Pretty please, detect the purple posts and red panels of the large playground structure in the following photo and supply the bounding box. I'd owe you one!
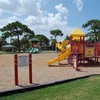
[68,36,100,70]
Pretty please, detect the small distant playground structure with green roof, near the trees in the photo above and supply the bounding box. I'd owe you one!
[29,38,39,54]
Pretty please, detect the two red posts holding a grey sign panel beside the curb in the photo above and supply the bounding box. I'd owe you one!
[14,54,32,85]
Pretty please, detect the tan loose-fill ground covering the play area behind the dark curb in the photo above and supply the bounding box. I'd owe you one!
[0,52,100,92]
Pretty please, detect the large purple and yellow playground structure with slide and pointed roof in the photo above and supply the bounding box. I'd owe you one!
[48,28,100,70]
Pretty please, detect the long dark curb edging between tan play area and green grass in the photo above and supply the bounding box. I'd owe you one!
[0,74,100,97]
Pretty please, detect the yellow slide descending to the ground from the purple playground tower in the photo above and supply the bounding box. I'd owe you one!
[48,45,71,65]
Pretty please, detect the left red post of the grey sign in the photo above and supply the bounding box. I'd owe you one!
[14,54,18,85]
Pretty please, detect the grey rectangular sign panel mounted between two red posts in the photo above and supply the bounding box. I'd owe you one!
[18,55,29,67]
